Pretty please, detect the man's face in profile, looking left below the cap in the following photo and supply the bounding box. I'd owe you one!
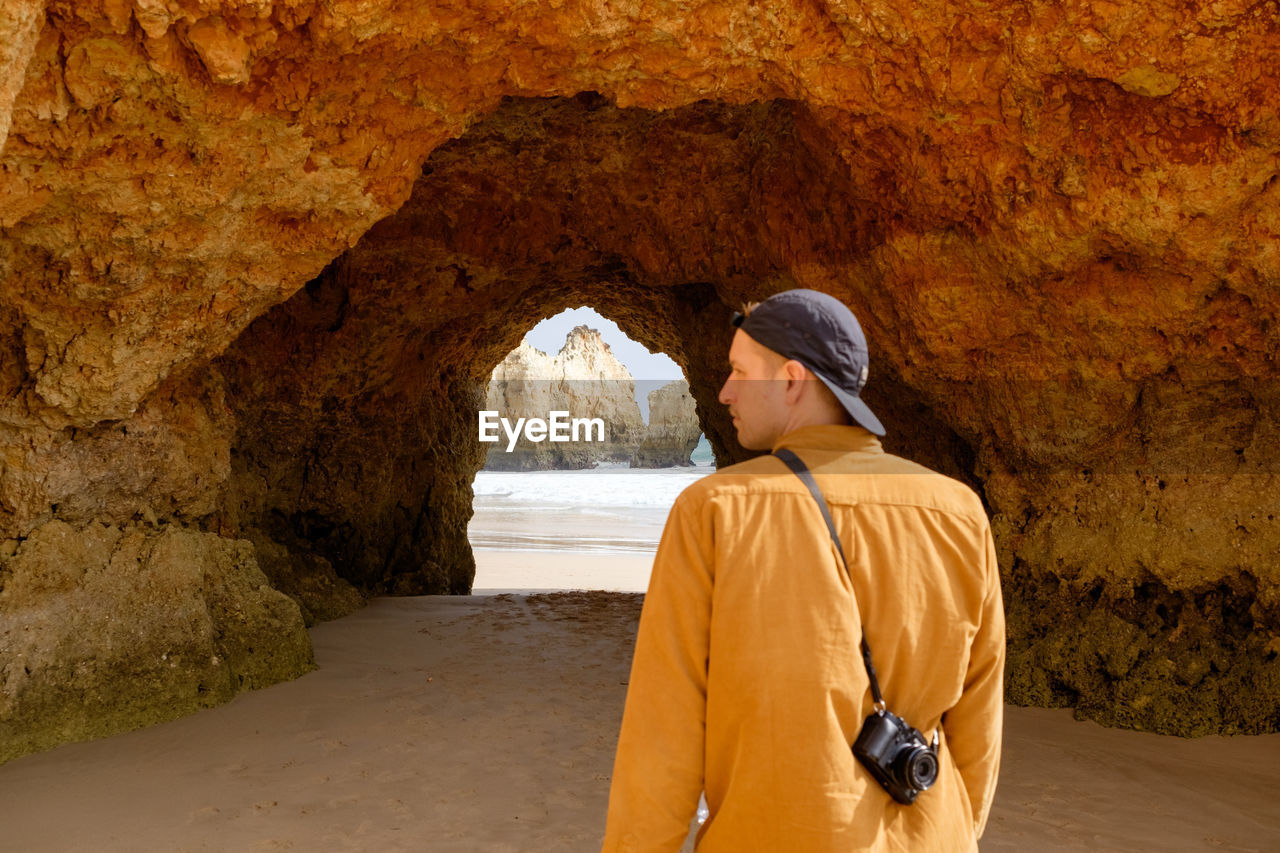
[719,329,787,450]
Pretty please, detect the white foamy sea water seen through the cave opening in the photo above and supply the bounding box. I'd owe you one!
[467,465,716,555]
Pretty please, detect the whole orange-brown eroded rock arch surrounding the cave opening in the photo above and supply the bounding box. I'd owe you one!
[0,0,1280,754]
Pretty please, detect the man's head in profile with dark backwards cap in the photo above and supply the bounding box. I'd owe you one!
[719,289,884,450]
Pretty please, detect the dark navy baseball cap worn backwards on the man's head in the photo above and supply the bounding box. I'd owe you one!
[733,289,884,435]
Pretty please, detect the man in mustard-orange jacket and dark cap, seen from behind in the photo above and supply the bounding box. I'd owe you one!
[604,289,1005,853]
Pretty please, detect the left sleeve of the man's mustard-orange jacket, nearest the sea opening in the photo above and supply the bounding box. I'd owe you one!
[603,498,713,853]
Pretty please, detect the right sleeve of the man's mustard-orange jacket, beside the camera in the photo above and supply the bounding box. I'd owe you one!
[943,528,1005,838]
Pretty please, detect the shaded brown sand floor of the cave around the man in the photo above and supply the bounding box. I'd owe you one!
[0,555,1280,852]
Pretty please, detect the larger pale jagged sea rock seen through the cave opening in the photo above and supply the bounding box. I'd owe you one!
[485,325,645,471]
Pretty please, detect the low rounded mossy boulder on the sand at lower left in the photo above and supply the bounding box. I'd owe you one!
[0,520,314,762]
